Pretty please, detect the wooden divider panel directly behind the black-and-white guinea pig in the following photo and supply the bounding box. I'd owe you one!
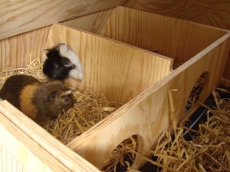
[43,24,173,103]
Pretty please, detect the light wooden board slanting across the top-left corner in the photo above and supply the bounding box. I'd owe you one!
[0,0,125,40]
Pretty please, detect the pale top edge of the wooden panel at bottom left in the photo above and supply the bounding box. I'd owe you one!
[0,100,99,172]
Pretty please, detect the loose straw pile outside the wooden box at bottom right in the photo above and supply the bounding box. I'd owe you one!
[131,89,230,172]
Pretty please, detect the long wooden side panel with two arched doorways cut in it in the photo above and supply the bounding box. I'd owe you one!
[67,33,230,169]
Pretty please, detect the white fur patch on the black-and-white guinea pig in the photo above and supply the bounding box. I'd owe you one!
[59,44,83,80]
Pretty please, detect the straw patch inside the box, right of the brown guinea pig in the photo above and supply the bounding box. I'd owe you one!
[44,88,121,144]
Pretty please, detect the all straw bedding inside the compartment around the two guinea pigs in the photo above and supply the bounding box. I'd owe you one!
[0,58,121,144]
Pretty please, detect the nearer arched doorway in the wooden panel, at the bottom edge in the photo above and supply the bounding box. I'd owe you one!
[102,135,139,172]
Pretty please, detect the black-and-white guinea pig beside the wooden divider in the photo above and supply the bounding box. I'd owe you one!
[43,43,83,81]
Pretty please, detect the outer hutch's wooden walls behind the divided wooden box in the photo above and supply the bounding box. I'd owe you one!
[0,0,230,80]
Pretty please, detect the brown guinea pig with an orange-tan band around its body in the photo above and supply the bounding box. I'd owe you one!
[0,75,75,125]
